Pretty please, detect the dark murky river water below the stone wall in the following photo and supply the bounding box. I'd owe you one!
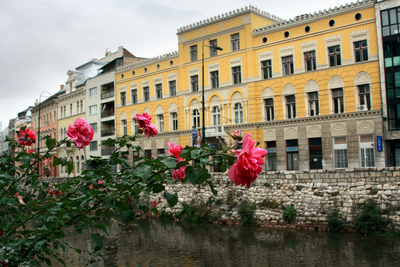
[55,219,400,267]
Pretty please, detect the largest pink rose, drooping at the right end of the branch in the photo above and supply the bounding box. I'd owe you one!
[228,133,267,188]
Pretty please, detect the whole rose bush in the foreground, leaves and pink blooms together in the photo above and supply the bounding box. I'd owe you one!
[0,114,266,266]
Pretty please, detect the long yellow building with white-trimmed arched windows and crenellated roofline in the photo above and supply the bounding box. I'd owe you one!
[116,1,384,171]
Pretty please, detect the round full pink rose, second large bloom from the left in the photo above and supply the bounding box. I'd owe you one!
[66,117,94,148]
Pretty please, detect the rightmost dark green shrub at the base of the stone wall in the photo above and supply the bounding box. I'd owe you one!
[355,199,390,235]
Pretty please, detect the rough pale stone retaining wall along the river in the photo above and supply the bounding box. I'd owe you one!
[159,168,400,230]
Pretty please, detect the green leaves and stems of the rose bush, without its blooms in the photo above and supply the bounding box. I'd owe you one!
[0,128,238,266]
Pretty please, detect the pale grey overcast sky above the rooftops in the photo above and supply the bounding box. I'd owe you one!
[0,0,344,128]
